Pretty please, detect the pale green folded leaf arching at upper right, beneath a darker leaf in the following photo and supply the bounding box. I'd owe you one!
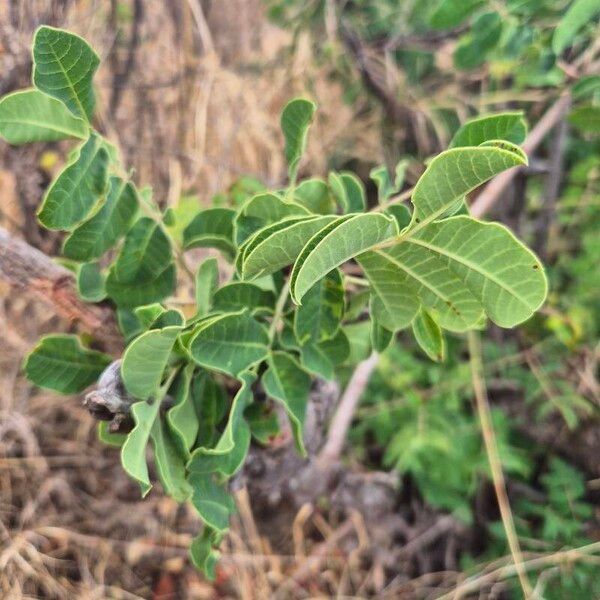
[412,142,527,222]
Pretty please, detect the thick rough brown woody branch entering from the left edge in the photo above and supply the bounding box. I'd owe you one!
[0,227,123,354]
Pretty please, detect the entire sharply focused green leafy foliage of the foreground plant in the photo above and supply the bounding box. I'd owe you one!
[0,26,547,574]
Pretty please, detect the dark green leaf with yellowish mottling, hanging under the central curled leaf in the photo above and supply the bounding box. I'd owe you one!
[294,269,344,344]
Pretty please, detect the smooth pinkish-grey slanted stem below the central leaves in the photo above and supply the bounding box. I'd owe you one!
[318,352,379,464]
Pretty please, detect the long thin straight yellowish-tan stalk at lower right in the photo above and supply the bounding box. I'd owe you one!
[468,331,533,598]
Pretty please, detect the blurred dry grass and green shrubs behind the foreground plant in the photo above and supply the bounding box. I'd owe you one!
[0,0,600,599]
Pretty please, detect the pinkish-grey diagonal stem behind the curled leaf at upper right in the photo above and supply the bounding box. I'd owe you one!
[471,91,571,217]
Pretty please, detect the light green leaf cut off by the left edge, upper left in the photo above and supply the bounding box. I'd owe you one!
[0,89,89,145]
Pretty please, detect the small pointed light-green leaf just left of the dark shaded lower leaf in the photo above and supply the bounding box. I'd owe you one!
[166,364,199,458]
